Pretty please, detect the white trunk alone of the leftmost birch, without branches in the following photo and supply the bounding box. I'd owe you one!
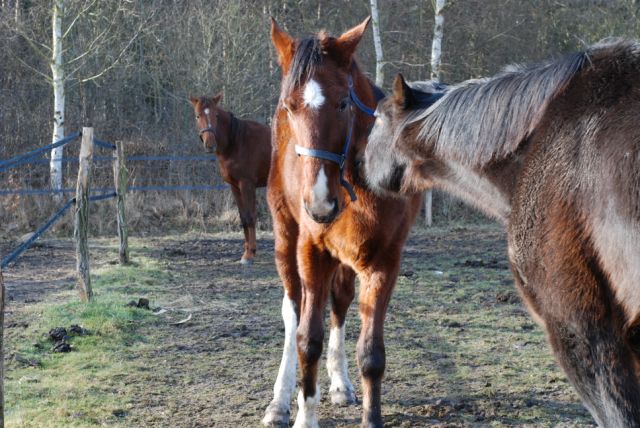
[49,0,64,194]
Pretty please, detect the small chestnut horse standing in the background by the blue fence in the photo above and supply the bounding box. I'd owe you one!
[189,93,271,264]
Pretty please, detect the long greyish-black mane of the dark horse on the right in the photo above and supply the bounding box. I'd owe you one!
[404,40,640,166]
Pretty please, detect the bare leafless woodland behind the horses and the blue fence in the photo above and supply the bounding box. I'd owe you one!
[0,0,640,237]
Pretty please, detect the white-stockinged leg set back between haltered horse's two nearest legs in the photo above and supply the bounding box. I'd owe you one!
[327,265,356,405]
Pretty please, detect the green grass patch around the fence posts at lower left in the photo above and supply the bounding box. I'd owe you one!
[5,257,170,427]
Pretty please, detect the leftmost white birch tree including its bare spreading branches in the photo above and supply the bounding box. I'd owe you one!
[8,0,146,190]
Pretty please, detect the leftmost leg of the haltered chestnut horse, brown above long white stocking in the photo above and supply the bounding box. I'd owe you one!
[262,213,300,427]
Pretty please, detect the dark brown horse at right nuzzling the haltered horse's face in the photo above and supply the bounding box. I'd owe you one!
[365,41,640,428]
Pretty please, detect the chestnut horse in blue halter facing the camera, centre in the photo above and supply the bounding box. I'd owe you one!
[263,19,420,427]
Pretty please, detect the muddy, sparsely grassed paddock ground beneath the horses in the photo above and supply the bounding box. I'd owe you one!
[0,226,593,427]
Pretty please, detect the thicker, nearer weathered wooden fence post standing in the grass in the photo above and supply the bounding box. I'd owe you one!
[73,128,93,302]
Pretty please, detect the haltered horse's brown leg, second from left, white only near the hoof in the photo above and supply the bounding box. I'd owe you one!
[294,241,337,428]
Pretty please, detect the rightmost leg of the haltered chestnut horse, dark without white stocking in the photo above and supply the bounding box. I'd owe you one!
[357,257,399,428]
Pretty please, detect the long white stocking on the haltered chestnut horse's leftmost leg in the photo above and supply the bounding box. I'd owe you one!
[262,292,298,426]
